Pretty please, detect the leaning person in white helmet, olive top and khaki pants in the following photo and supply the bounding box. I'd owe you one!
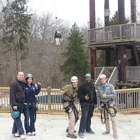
[60,76,79,139]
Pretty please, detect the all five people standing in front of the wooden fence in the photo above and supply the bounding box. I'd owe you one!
[10,72,118,139]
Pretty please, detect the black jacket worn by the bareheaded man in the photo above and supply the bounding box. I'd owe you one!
[10,79,25,106]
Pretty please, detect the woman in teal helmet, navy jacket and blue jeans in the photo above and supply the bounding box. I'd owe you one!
[24,74,41,136]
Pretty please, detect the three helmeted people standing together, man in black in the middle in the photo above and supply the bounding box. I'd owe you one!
[60,73,118,139]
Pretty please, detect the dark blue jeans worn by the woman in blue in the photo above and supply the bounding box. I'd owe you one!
[24,107,35,133]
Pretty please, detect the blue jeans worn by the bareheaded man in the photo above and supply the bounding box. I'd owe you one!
[12,104,24,135]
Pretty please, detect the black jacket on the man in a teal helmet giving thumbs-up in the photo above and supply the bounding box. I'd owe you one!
[78,82,97,104]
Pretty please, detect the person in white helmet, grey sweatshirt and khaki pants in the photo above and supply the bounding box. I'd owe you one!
[97,74,118,139]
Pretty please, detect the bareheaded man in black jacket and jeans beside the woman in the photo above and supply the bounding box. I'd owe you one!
[10,72,26,139]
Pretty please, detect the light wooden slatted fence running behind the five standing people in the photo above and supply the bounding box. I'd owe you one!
[0,88,140,114]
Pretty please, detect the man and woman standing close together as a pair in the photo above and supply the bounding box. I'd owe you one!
[10,72,41,139]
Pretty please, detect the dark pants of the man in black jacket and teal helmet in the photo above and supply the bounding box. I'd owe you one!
[79,103,94,133]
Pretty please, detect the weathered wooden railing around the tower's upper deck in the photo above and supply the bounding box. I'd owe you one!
[88,23,140,44]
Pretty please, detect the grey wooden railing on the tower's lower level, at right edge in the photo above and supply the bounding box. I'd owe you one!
[126,66,140,82]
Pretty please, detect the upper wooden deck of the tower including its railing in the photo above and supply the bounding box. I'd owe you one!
[88,23,140,49]
